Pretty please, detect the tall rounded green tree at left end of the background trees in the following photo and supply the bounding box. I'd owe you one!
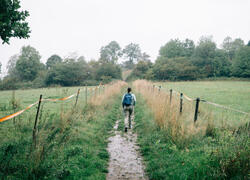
[16,46,44,81]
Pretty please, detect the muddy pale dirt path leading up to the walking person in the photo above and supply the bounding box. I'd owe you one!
[106,121,148,180]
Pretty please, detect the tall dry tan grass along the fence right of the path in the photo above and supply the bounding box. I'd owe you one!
[133,80,212,143]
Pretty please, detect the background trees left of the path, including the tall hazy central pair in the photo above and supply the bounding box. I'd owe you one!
[0,41,149,90]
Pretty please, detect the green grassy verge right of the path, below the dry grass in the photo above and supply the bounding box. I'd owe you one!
[135,94,250,179]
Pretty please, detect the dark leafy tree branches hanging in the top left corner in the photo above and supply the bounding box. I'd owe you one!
[0,0,30,44]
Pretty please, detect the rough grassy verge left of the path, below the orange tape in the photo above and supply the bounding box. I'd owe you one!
[0,83,125,179]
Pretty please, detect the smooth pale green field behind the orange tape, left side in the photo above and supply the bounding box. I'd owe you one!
[0,87,100,121]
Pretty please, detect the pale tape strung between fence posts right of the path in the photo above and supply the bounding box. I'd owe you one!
[153,85,250,115]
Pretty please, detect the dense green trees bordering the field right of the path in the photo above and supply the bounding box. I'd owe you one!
[128,36,250,80]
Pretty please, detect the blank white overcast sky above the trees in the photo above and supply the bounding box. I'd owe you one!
[0,0,250,74]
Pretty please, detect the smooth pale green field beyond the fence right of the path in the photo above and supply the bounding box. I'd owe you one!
[155,81,250,126]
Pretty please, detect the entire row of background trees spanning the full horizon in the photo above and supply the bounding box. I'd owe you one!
[0,36,250,90]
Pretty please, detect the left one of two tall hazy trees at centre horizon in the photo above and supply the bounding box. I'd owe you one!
[100,41,122,64]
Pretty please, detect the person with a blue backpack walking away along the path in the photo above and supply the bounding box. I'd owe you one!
[122,87,136,132]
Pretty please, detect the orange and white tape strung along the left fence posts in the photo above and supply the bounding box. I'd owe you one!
[0,85,104,123]
